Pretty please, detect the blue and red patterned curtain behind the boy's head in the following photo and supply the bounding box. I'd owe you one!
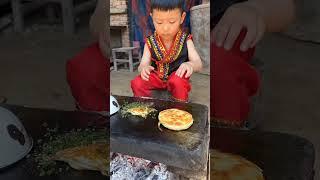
[129,0,202,47]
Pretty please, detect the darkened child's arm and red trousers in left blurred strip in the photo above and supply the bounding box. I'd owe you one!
[66,0,110,113]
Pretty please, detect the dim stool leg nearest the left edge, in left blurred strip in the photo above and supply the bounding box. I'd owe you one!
[11,0,24,32]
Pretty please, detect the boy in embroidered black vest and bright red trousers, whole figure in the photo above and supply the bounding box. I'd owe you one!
[131,0,202,101]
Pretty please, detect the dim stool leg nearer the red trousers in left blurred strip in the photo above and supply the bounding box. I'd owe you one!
[61,0,75,34]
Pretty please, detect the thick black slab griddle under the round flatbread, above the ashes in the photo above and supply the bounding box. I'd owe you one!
[110,96,209,171]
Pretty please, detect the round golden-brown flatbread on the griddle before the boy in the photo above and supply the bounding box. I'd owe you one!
[158,108,193,131]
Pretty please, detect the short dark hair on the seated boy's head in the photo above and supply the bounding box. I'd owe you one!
[151,0,185,12]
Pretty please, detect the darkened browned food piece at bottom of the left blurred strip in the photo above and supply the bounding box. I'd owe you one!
[53,143,109,176]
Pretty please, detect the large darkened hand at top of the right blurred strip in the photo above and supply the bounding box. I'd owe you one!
[213,2,266,51]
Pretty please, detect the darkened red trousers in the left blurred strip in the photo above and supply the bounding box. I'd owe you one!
[66,43,110,111]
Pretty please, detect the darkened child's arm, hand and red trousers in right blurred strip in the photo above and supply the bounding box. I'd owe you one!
[211,0,294,126]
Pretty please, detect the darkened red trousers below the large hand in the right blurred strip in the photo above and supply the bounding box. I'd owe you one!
[210,31,260,124]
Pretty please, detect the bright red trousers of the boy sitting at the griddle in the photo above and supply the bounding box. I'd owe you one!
[131,72,191,101]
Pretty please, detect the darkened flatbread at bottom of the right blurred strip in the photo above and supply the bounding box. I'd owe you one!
[210,150,264,180]
